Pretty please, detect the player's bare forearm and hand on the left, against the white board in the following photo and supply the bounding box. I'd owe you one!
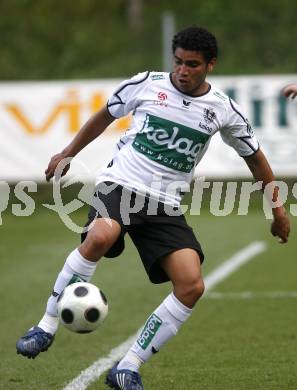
[45,107,115,181]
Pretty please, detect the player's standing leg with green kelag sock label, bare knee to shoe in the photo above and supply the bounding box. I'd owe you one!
[106,248,204,390]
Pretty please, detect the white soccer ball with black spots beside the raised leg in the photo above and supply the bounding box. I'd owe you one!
[58,282,108,333]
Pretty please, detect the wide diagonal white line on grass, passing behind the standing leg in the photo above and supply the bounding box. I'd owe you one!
[63,241,266,390]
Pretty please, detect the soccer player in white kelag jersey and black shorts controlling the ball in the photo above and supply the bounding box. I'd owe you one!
[17,27,290,390]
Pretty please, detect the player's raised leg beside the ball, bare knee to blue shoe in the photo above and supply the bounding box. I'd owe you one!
[16,218,121,358]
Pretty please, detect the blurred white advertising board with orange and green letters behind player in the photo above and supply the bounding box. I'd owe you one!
[0,75,297,181]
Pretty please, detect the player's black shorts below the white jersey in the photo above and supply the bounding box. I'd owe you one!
[81,182,204,283]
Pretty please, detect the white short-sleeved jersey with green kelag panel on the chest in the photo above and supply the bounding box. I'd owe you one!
[96,72,259,206]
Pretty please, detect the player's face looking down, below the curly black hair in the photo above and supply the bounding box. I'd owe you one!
[172,47,216,96]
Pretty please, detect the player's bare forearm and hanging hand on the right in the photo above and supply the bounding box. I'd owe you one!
[244,149,290,243]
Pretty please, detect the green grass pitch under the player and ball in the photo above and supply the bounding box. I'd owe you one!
[0,210,297,390]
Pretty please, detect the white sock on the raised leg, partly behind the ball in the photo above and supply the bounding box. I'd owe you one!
[38,249,97,334]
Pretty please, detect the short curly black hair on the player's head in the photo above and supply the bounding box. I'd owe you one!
[172,26,218,62]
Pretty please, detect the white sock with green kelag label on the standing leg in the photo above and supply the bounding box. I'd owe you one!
[118,293,192,372]
